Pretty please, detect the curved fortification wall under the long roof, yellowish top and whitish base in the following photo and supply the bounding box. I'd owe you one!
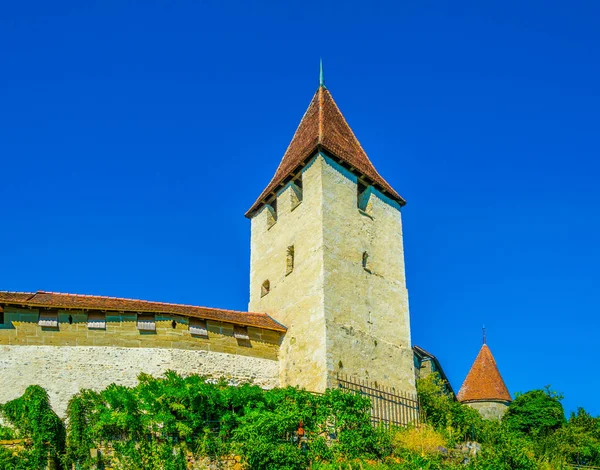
[0,307,280,415]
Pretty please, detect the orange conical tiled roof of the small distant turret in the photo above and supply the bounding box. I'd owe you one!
[456,344,512,402]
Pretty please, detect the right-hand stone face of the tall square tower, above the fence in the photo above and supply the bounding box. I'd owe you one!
[322,158,415,394]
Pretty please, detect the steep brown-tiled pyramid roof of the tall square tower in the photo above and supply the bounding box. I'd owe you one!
[246,86,406,217]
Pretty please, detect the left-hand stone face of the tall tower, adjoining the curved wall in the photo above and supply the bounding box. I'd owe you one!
[248,158,327,391]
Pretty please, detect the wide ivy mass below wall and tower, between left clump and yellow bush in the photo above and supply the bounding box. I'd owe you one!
[61,372,380,470]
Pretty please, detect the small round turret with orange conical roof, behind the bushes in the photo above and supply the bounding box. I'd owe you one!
[456,343,512,419]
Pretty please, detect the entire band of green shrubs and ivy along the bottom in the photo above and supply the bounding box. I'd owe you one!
[0,372,600,470]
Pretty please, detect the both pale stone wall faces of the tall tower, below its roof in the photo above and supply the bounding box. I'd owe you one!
[249,154,415,394]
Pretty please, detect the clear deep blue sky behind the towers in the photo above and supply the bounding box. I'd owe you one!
[0,0,600,415]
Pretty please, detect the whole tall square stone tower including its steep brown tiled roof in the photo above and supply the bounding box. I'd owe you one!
[246,75,415,393]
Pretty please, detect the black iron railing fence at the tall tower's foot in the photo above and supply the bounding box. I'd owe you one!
[336,374,421,426]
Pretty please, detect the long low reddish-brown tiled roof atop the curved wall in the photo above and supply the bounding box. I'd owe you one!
[0,291,286,332]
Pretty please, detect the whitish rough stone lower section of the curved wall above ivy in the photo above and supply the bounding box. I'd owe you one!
[0,345,279,416]
